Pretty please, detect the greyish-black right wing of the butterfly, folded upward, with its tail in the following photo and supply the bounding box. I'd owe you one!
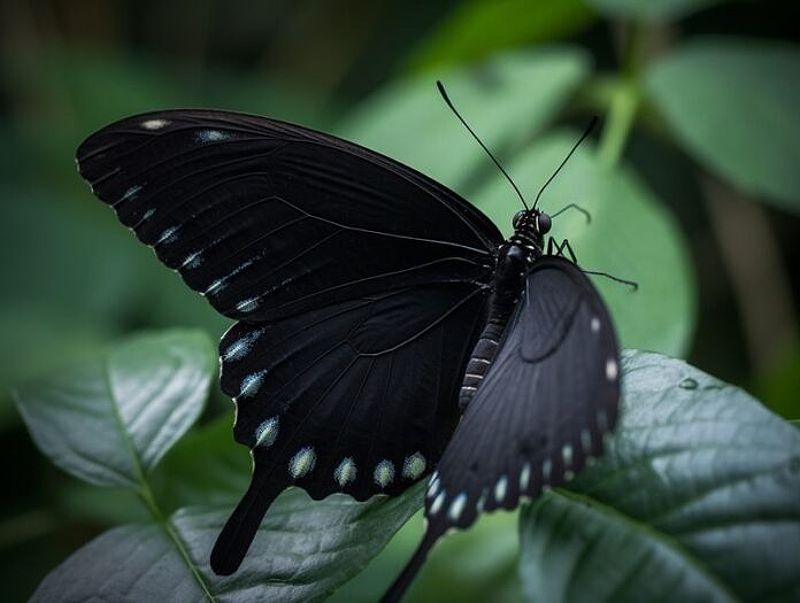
[384,256,620,601]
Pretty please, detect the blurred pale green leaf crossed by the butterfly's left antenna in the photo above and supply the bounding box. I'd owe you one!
[341,49,588,194]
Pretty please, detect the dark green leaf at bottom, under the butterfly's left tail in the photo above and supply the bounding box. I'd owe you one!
[31,484,424,603]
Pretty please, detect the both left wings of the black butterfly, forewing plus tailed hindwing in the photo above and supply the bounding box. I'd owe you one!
[73,111,501,574]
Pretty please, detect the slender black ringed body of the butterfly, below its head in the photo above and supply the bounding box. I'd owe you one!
[458,243,525,413]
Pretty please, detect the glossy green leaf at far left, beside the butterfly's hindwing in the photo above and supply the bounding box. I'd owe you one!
[15,330,215,488]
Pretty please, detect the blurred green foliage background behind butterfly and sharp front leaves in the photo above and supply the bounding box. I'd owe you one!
[0,0,800,601]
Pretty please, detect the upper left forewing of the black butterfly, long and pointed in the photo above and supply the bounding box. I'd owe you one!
[78,111,500,321]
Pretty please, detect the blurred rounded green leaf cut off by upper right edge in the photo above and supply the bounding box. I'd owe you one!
[645,39,800,212]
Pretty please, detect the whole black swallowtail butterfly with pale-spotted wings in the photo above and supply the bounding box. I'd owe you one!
[77,88,619,599]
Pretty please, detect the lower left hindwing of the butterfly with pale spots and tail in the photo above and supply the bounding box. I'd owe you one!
[211,285,486,574]
